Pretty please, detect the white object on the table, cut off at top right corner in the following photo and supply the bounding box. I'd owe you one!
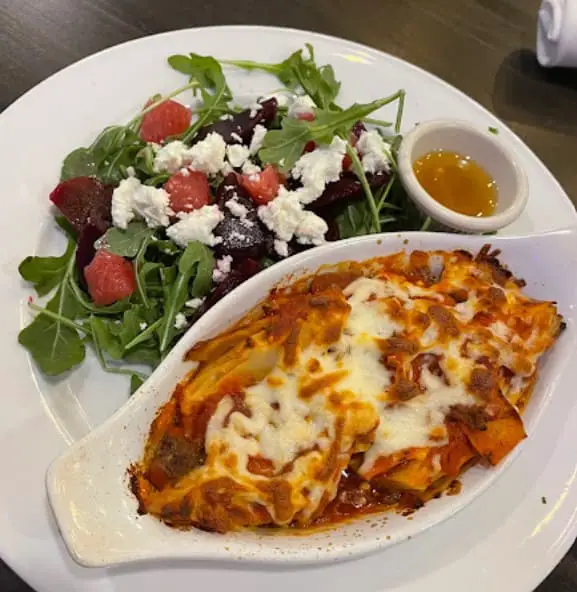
[537,0,577,68]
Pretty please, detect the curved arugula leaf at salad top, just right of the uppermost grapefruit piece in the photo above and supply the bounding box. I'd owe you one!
[168,53,232,142]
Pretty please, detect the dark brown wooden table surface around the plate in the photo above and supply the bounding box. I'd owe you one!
[0,0,577,592]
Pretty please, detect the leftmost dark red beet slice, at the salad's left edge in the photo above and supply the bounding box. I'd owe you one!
[50,177,113,234]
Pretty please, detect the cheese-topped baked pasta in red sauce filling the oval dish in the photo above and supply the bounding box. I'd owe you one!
[130,246,564,533]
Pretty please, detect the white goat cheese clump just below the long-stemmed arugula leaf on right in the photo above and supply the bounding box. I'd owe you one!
[292,136,347,205]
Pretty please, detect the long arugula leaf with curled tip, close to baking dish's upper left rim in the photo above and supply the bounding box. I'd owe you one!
[159,241,214,353]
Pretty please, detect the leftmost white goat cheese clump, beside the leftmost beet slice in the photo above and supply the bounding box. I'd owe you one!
[110,177,173,230]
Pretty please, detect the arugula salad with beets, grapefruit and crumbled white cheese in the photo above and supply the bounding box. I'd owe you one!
[18,45,428,391]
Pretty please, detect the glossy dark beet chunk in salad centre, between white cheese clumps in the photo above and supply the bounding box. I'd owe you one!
[214,173,270,259]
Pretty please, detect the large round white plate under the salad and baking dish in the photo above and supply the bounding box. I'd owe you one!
[0,27,577,592]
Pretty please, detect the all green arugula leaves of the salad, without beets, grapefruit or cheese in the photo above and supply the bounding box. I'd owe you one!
[18,44,432,392]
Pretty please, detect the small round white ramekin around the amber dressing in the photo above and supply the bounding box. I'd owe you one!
[397,119,529,234]
